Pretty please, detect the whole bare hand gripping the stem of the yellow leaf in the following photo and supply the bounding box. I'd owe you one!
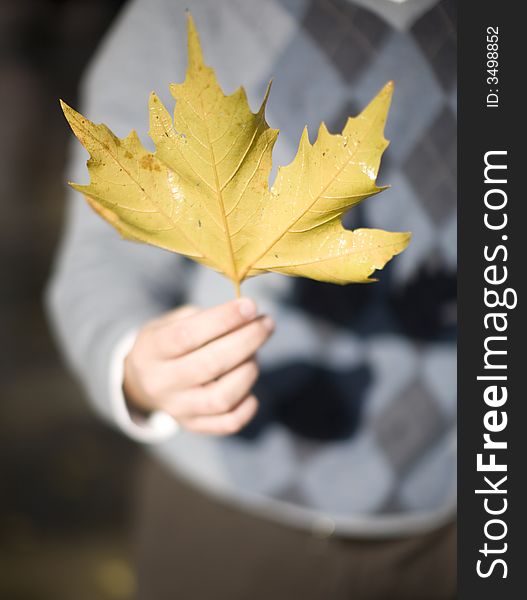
[123,298,274,435]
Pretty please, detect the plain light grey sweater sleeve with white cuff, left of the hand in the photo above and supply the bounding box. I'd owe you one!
[45,0,188,441]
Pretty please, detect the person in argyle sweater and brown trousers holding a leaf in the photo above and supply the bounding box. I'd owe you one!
[48,0,456,600]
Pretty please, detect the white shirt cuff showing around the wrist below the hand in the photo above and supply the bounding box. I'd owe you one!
[109,331,179,444]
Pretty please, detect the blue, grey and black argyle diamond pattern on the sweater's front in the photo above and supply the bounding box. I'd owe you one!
[208,0,456,514]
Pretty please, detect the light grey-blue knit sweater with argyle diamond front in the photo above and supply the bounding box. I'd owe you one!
[47,0,456,536]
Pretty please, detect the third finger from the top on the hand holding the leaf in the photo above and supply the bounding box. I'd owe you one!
[163,360,258,420]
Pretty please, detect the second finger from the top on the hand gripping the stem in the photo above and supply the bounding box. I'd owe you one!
[173,317,274,389]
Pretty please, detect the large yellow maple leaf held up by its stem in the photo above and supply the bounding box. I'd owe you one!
[61,15,410,295]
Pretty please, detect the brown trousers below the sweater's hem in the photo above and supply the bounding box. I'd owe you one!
[135,458,456,600]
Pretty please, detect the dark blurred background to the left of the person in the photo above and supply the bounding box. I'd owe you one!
[0,0,142,600]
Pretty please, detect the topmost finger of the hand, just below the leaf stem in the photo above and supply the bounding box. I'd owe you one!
[156,298,257,358]
